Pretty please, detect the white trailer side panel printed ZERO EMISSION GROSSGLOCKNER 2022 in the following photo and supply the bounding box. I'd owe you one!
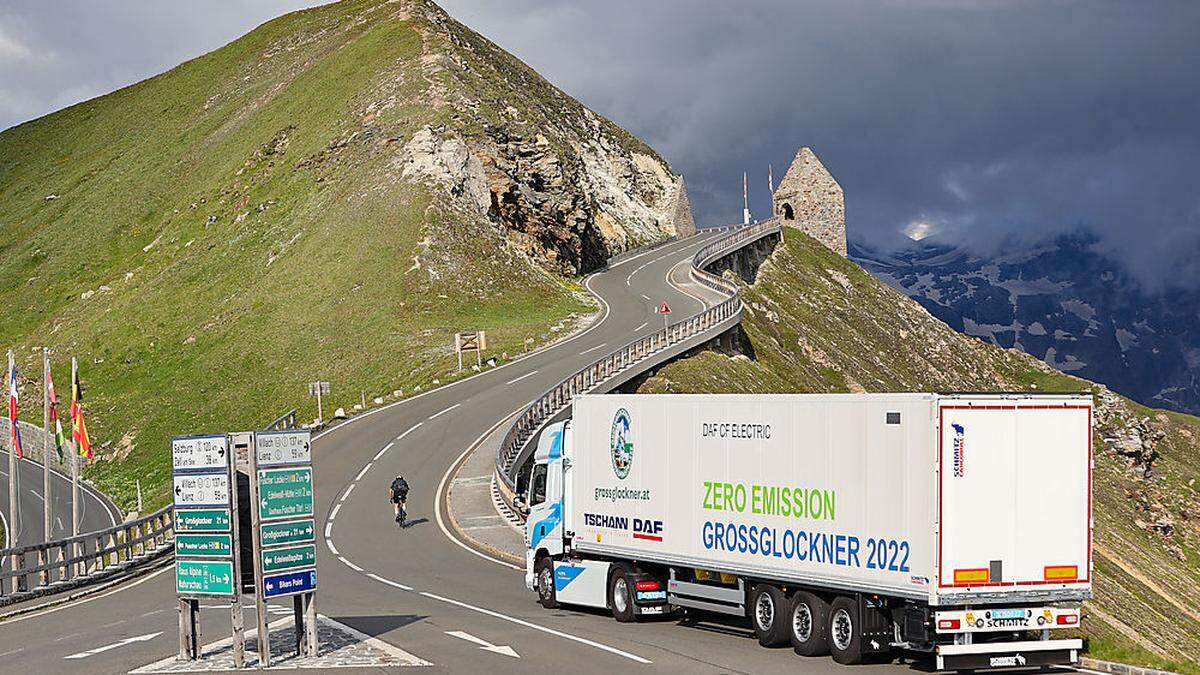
[568,394,937,598]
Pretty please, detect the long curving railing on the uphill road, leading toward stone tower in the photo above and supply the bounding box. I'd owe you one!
[496,219,780,495]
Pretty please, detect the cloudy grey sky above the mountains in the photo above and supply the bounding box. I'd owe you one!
[0,0,1200,287]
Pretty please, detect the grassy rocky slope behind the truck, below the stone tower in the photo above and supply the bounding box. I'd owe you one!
[638,228,1200,673]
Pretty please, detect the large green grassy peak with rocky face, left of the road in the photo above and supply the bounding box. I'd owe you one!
[0,0,673,507]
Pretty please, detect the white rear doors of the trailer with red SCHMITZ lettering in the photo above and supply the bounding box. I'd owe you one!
[937,396,1092,596]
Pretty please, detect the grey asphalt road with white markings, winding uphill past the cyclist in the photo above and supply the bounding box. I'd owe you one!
[0,234,926,674]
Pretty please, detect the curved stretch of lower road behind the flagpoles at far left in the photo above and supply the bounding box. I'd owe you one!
[0,450,120,547]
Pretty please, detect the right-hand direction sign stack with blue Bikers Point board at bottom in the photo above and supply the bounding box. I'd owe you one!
[250,430,318,668]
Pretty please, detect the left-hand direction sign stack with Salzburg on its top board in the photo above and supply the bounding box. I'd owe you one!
[170,434,245,668]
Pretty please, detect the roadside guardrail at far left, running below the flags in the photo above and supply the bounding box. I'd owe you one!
[0,506,174,607]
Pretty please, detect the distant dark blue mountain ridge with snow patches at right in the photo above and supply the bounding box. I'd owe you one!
[850,232,1200,413]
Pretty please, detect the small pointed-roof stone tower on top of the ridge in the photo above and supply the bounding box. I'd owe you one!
[770,147,846,256]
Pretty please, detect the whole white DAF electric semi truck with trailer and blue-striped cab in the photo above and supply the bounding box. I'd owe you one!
[526,394,1092,670]
